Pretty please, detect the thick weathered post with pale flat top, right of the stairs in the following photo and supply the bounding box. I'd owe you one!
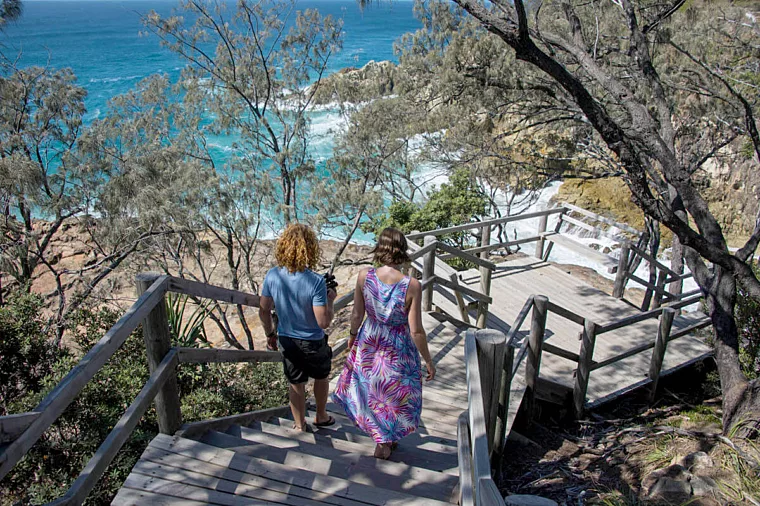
[475,329,507,456]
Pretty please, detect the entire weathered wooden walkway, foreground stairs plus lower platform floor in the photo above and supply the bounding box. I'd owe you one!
[113,256,711,506]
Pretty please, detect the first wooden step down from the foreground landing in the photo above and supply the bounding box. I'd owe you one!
[200,431,459,501]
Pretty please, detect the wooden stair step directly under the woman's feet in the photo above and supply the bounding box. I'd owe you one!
[232,426,458,476]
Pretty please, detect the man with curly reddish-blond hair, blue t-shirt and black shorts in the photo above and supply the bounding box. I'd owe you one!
[259,223,336,431]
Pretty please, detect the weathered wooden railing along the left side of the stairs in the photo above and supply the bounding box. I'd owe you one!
[0,274,353,505]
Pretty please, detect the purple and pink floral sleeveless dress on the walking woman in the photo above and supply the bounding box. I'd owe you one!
[332,269,422,443]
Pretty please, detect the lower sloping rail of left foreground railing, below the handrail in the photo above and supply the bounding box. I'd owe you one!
[51,350,179,506]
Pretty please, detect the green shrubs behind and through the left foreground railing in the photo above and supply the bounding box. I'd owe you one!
[0,295,287,505]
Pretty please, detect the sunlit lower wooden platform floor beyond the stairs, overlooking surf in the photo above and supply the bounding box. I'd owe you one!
[433,255,712,407]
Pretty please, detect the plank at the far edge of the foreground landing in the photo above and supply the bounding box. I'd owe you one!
[151,434,454,506]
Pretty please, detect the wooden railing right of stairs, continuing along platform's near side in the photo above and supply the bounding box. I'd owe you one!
[457,295,710,506]
